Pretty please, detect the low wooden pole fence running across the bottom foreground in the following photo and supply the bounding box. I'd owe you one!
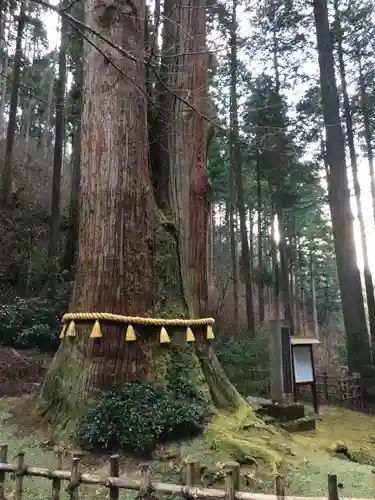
[0,445,368,500]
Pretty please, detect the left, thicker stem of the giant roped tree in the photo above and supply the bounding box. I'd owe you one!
[40,0,154,421]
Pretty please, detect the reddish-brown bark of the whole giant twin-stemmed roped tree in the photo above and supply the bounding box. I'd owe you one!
[39,0,243,426]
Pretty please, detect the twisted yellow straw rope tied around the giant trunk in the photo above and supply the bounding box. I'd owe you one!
[62,313,215,326]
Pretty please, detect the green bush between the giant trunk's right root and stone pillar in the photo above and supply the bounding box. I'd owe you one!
[216,338,269,397]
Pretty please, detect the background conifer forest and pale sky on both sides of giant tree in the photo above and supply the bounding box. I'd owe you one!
[0,0,375,393]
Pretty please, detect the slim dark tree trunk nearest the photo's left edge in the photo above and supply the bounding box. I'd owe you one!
[1,2,26,205]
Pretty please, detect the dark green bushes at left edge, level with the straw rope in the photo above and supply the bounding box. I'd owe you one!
[0,298,66,351]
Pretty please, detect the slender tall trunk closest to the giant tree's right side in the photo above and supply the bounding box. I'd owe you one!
[230,0,255,335]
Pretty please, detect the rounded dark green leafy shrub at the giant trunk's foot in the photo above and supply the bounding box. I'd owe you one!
[78,382,205,454]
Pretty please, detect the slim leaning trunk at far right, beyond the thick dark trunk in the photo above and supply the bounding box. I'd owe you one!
[334,0,375,356]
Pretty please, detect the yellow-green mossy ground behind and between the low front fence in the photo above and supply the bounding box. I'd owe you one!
[0,399,375,500]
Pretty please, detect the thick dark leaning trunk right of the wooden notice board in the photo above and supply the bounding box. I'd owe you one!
[314,0,372,375]
